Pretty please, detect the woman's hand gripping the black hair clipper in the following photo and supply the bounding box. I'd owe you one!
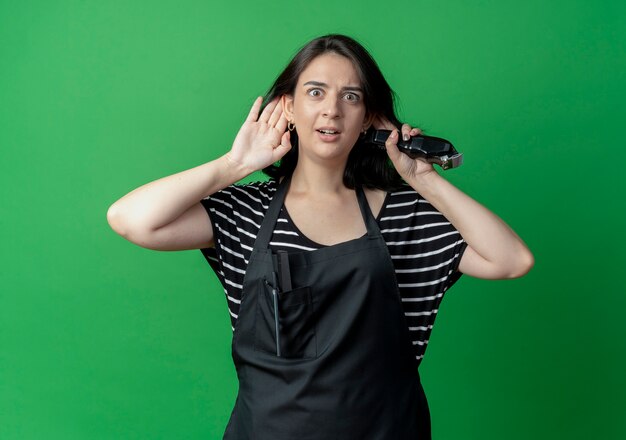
[372,118,437,182]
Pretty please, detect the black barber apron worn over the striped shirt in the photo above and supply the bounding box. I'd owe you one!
[223,178,431,440]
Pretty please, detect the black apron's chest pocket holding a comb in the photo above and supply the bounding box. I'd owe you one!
[254,282,317,359]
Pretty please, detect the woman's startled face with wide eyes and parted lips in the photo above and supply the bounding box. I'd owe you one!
[282,52,370,165]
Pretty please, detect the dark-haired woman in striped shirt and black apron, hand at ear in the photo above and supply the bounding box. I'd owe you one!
[108,35,533,440]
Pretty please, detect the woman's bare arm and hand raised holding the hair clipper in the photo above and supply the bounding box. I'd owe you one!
[387,127,534,279]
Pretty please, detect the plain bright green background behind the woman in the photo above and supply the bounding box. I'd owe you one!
[0,0,626,440]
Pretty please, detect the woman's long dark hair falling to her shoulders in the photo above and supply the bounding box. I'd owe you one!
[263,34,403,191]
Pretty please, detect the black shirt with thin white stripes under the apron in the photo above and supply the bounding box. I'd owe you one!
[201,180,467,362]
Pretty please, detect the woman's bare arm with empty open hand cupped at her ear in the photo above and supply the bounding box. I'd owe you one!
[107,97,291,250]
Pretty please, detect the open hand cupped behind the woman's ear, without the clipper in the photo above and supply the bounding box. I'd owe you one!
[226,96,291,175]
